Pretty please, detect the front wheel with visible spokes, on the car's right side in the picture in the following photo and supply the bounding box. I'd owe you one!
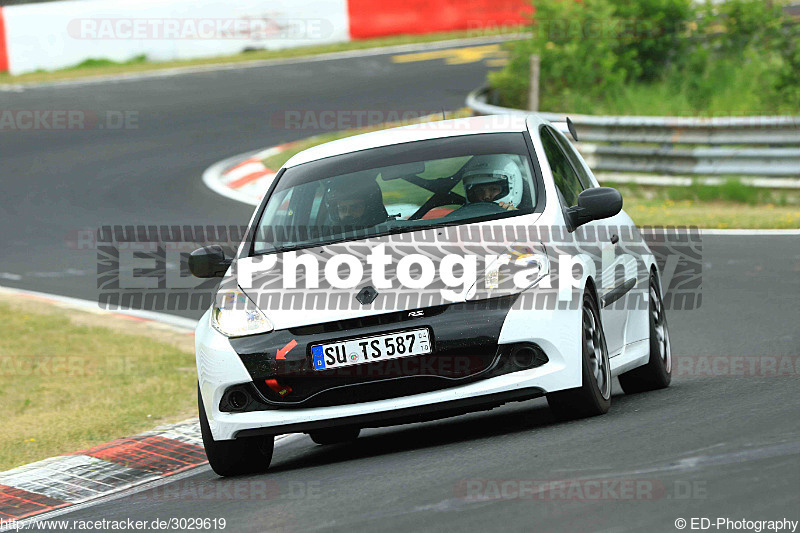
[547,291,611,419]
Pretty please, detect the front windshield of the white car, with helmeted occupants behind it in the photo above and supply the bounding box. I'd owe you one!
[252,133,537,254]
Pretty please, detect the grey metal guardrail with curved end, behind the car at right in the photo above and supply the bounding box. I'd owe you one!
[467,88,800,180]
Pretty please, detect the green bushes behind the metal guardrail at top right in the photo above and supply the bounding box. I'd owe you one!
[489,0,800,115]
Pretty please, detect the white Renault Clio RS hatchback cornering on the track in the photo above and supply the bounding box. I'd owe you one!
[189,116,671,476]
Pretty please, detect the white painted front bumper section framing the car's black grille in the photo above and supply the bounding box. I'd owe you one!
[195,284,581,440]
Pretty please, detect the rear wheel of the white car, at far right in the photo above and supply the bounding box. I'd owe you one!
[619,273,672,394]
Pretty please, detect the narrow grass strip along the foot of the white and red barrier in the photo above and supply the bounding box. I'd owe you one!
[0,27,519,84]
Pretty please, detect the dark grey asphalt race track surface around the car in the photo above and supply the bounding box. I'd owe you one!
[0,40,800,531]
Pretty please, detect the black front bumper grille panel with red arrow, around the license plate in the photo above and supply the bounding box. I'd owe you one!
[228,296,516,410]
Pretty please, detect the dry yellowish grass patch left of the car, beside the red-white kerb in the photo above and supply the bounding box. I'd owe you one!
[0,302,196,471]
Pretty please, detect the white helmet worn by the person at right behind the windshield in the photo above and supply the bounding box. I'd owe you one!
[462,154,523,208]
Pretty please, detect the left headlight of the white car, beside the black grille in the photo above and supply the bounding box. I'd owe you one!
[211,287,275,337]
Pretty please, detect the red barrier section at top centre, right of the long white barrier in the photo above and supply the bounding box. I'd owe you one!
[347,0,532,39]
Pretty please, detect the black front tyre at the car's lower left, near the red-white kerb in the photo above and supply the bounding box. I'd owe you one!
[197,387,275,476]
